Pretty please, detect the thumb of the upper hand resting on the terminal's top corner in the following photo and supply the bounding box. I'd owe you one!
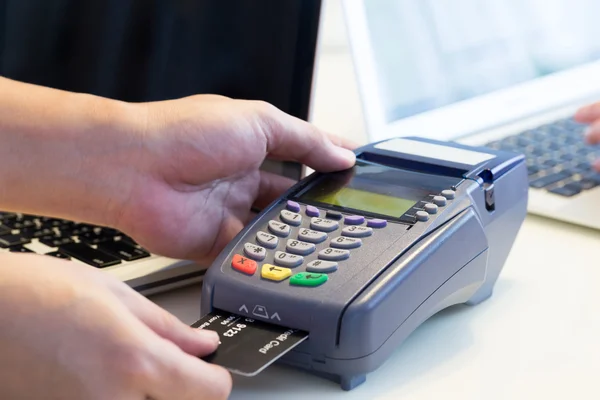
[251,103,357,172]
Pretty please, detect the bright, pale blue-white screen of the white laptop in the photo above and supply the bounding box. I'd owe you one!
[363,0,600,123]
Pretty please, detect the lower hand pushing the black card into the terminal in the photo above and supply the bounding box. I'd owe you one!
[0,254,231,400]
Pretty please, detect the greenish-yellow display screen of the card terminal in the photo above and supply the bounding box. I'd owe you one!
[298,160,438,218]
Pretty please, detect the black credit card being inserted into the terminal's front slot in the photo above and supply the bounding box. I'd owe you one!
[192,311,308,376]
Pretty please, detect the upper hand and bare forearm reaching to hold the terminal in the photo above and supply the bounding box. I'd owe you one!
[0,77,354,263]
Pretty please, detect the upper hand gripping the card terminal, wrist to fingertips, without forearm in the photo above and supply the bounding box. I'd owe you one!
[112,95,354,262]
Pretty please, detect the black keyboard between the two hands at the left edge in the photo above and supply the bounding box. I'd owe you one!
[0,212,150,268]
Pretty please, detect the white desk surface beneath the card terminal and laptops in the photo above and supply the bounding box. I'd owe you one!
[153,49,600,400]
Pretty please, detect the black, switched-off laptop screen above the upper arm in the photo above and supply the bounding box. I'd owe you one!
[0,0,319,118]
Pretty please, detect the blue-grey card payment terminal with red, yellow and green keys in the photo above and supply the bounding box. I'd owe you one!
[201,138,528,390]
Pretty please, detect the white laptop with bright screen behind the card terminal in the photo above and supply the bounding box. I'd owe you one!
[343,0,600,229]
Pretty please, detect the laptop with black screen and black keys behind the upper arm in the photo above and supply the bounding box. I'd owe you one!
[0,0,321,295]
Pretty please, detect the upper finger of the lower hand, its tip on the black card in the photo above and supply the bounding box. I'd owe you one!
[118,292,219,357]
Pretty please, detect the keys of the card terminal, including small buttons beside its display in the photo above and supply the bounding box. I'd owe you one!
[231,190,454,287]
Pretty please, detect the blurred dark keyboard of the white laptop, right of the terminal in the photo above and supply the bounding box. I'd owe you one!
[486,118,600,197]
